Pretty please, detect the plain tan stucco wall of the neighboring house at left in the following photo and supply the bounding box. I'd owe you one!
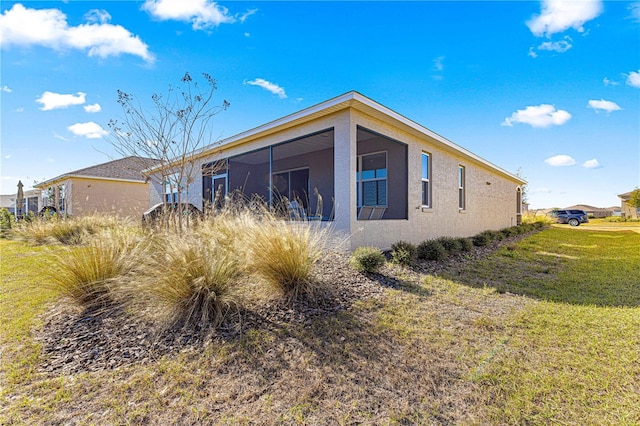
[68,178,149,219]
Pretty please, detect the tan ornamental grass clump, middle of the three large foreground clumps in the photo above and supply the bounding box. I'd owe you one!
[135,232,243,328]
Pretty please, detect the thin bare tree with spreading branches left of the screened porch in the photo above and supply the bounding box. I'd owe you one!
[109,72,230,231]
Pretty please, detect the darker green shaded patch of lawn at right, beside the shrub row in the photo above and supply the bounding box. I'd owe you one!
[448,228,640,307]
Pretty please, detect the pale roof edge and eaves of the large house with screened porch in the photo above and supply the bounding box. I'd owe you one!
[148,91,526,184]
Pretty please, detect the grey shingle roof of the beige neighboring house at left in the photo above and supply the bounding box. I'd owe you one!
[34,156,158,188]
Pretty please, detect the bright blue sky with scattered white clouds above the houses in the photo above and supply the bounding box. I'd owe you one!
[0,0,640,208]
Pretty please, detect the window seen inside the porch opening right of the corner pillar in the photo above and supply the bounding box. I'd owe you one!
[356,152,387,207]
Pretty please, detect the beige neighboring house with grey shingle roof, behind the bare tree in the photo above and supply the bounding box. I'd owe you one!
[35,157,157,218]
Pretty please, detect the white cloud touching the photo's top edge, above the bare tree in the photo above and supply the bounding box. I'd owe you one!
[142,0,257,30]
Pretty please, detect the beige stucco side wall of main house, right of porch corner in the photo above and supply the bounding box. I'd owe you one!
[350,111,518,248]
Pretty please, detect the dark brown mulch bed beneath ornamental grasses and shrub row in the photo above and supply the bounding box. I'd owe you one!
[36,235,536,375]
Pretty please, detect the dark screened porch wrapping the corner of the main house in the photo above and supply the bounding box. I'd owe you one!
[202,127,407,221]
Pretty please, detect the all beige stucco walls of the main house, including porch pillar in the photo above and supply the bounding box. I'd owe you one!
[145,109,518,248]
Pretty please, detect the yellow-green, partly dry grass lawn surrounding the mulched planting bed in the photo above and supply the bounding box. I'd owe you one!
[0,227,640,425]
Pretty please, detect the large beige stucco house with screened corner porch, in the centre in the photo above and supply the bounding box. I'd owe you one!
[147,92,526,248]
